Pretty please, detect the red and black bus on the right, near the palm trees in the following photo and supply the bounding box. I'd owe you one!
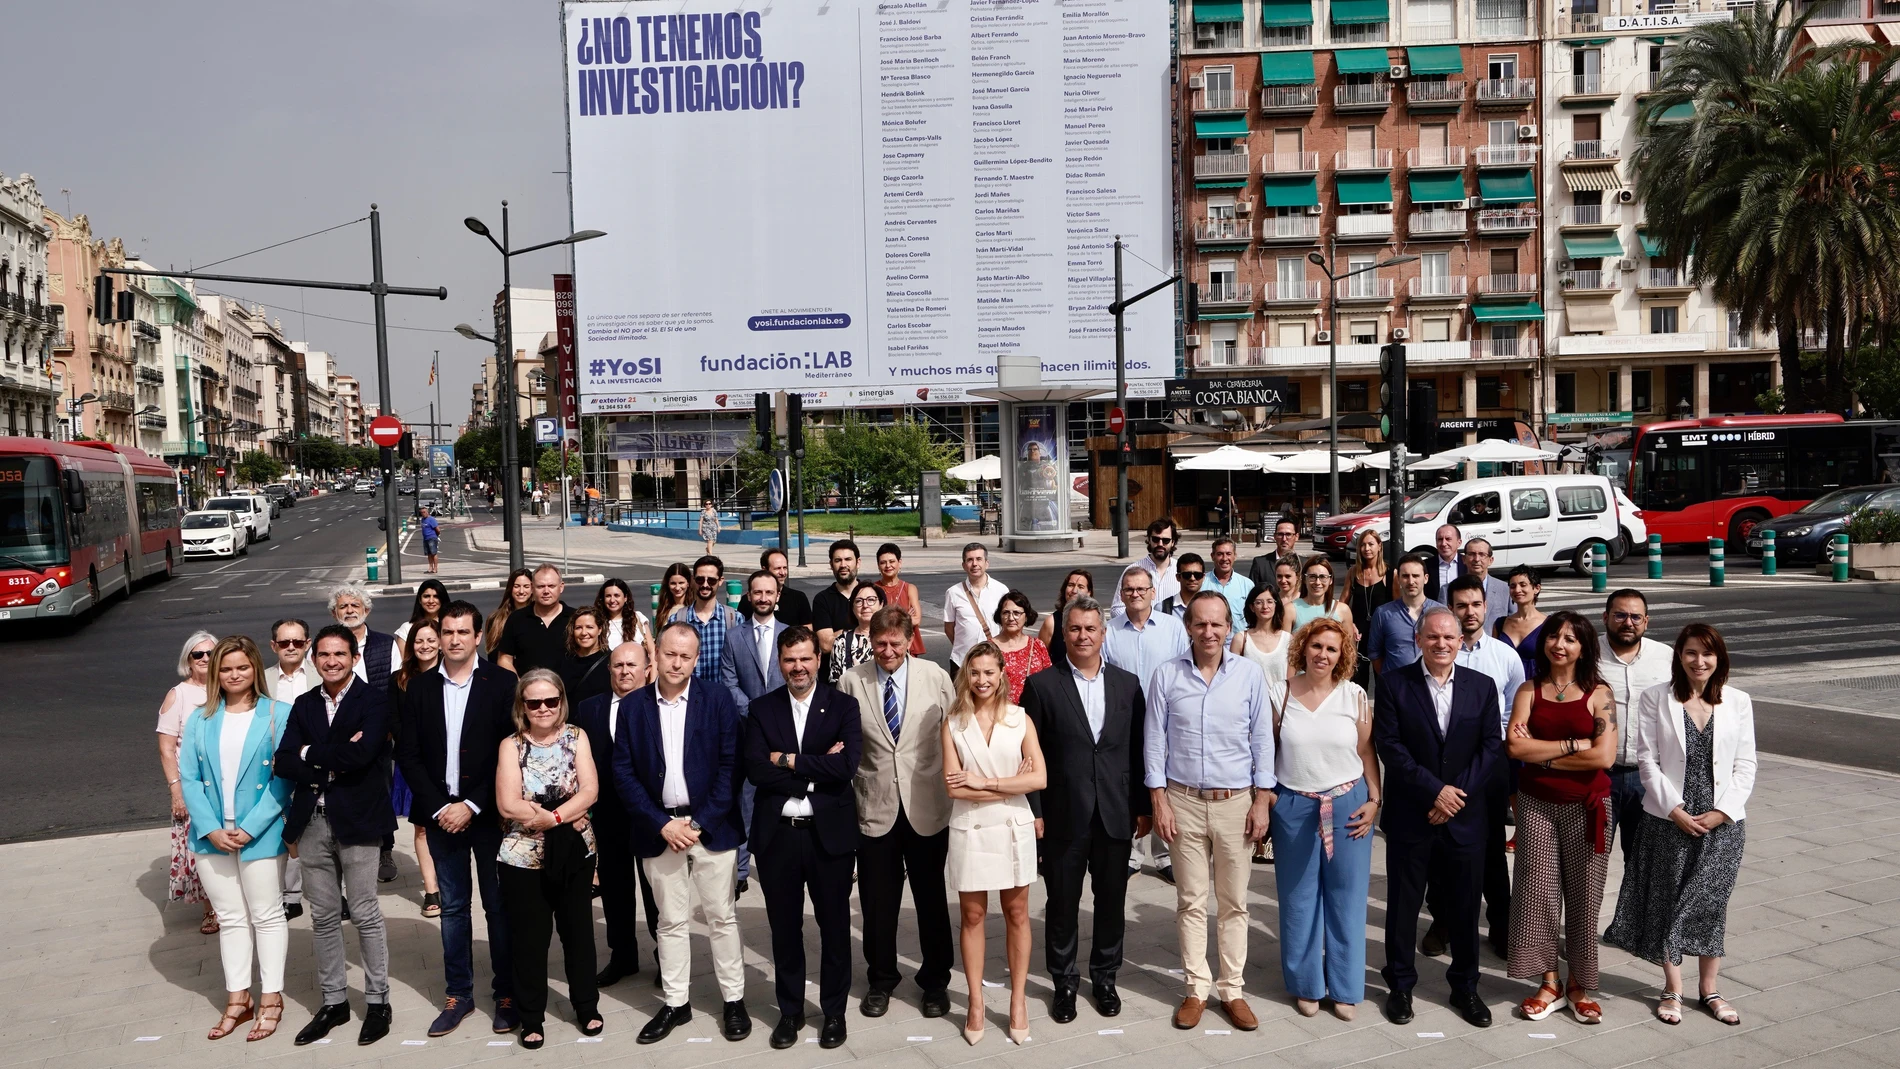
[1585,414,1900,549]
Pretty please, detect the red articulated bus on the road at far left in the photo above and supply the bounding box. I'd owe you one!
[0,437,184,621]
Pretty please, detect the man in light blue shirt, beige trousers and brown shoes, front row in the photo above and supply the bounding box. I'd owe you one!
[1142,591,1275,1031]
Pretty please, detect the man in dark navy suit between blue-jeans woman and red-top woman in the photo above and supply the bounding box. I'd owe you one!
[1372,606,1505,1027]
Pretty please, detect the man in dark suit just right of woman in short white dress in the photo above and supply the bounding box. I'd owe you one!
[1022,598,1151,1023]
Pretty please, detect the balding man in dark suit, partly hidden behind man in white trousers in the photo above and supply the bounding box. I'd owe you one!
[574,642,659,987]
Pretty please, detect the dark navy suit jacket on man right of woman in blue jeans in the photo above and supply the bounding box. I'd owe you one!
[1372,661,1505,849]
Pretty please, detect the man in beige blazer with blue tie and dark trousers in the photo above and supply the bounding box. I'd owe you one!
[838,610,956,1018]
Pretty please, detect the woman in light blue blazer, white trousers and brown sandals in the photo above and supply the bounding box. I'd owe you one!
[179,634,291,1042]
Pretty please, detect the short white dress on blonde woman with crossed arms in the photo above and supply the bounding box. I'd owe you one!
[948,704,1036,892]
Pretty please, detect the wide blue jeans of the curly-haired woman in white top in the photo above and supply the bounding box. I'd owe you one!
[1273,780,1372,1004]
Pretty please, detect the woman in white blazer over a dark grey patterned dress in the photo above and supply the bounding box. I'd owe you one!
[1604,623,1756,1025]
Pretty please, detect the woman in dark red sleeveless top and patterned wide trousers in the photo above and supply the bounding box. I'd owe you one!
[1505,611,1617,1025]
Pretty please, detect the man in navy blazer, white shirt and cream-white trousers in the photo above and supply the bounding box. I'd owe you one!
[614,621,752,1042]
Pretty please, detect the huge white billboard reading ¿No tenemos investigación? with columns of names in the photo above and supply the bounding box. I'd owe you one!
[564,0,1174,412]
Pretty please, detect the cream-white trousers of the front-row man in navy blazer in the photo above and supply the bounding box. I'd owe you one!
[640,843,745,1006]
